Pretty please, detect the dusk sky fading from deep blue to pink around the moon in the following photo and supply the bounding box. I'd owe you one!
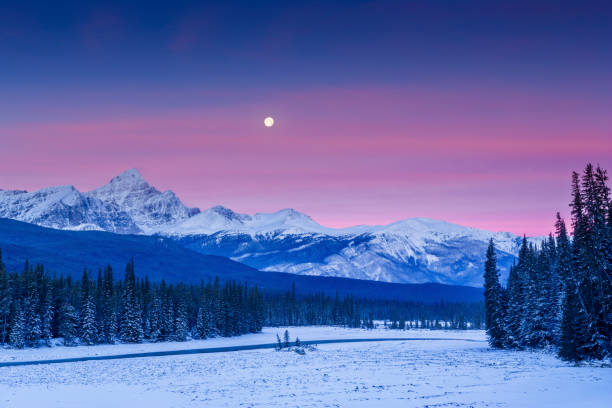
[0,0,612,235]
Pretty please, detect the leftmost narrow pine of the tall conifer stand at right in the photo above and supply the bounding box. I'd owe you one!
[484,238,506,348]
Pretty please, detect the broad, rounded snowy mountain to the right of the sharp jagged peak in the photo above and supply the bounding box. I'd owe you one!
[170,207,521,286]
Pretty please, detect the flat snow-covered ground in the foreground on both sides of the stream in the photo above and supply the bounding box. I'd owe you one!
[0,327,612,408]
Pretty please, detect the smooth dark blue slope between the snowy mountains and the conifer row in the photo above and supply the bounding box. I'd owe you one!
[0,219,482,302]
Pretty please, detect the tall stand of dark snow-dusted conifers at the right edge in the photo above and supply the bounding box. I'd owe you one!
[484,164,612,361]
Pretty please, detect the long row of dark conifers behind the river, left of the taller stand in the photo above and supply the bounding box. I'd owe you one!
[0,251,484,348]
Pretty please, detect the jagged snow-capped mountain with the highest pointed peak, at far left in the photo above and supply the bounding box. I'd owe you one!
[0,169,200,234]
